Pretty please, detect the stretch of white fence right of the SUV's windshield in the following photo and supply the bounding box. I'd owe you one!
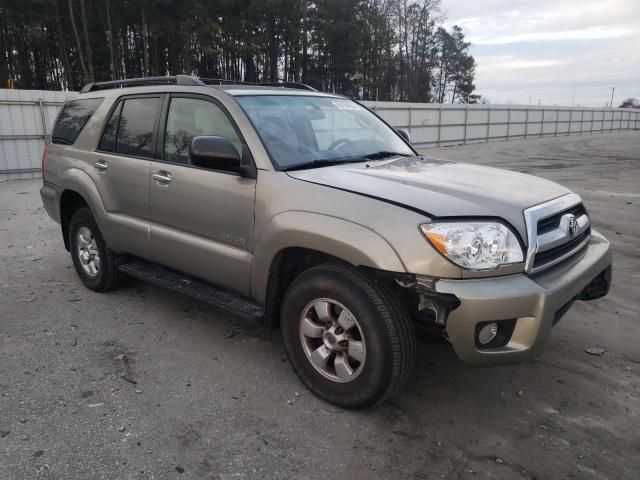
[364,102,640,147]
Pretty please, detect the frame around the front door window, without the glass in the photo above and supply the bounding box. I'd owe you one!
[153,92,255,177]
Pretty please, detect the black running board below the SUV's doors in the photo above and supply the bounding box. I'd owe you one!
[118,258,264,320]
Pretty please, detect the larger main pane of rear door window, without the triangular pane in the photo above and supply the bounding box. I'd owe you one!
[112,98,160,157]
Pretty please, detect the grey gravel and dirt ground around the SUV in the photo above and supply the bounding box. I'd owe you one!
[0,132,640,480]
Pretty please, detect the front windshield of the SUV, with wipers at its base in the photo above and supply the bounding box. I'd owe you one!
[236,95,414,169]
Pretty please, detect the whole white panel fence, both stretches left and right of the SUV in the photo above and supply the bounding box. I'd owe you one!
[0,90,640,181]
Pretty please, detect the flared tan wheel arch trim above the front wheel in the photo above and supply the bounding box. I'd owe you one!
[251,211,406,304]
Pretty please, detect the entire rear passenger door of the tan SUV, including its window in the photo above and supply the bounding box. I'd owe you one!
[91,94,163,258]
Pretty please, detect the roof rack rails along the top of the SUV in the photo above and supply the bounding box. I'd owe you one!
[80,75,317,93]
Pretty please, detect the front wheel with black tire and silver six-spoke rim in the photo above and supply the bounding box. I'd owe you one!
[281,264,416,409]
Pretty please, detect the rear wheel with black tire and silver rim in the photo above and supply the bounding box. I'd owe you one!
[68,208,118,292]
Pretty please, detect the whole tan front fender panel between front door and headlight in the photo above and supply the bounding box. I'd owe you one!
[251,171,460,301]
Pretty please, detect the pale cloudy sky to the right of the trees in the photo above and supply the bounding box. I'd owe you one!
[442,0,640,107]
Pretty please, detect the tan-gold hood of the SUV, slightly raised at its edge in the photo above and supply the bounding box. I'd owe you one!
[288,156,571,242]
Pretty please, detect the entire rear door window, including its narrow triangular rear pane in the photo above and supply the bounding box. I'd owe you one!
[98,97,160,157]
